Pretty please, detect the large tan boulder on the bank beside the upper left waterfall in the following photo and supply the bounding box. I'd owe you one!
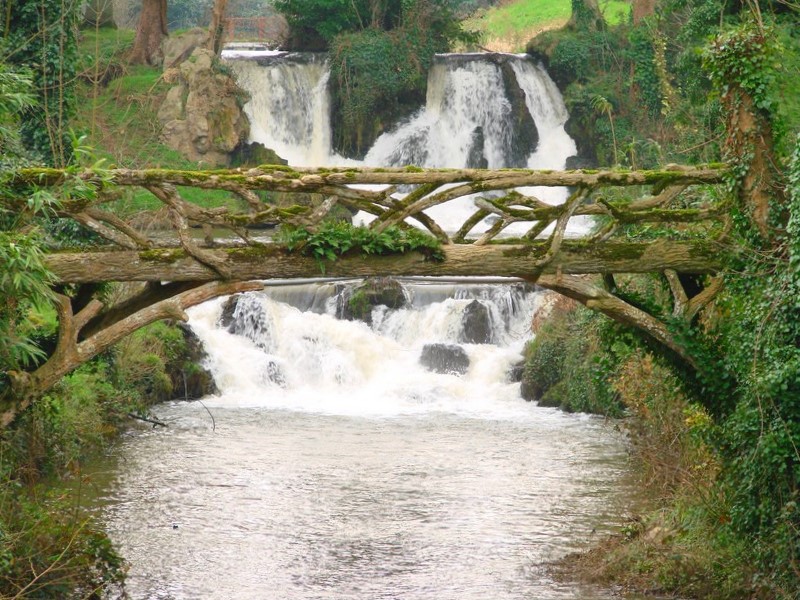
[158,47,250,167]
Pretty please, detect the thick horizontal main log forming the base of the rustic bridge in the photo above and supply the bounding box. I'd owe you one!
[46,240,722,283]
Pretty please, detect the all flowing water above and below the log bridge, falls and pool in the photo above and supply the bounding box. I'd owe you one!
[95,50,626,600]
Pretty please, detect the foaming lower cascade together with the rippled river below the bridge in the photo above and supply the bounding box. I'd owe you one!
[92,286,629,600]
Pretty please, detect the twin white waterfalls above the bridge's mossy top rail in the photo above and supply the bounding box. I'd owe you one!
[223,51,576,169]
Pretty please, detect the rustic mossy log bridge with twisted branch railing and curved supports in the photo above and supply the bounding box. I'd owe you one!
[0,165,731,426]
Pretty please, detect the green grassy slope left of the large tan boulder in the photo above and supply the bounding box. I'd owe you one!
[73,29,244,215]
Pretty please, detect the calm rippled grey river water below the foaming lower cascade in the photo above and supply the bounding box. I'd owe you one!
[98,403,625,600]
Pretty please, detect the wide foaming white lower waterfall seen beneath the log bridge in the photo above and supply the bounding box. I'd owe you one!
[190,282,541,415]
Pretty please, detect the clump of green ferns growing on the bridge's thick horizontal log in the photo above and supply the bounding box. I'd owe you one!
[277,221,444,265]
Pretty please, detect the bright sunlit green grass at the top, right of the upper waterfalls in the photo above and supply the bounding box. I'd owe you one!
[465,0,630,52]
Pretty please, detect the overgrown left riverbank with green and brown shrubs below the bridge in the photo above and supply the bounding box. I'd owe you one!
[0,315,214,599]
